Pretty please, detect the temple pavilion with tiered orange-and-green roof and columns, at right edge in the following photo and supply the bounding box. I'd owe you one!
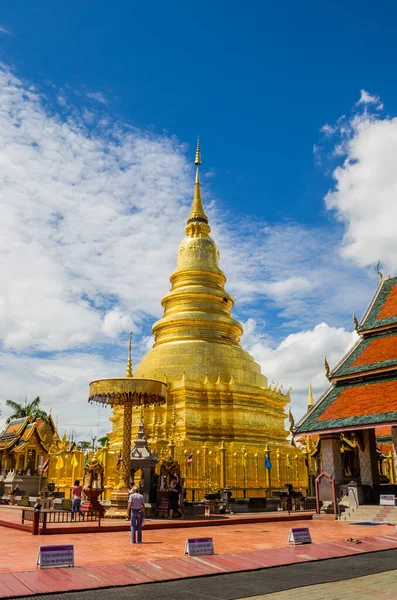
[294,271,397,503]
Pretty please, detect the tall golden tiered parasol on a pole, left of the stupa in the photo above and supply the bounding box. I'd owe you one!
[88,334,167,512]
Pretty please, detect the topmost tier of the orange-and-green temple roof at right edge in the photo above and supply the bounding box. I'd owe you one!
[359,277,397,333]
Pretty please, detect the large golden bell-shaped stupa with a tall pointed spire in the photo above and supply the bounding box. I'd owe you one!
[109,138,290,453]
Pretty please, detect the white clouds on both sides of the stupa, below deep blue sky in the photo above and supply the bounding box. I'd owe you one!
[0,68,397,436]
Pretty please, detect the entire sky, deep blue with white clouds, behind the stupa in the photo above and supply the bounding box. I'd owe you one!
[0,0,397,435]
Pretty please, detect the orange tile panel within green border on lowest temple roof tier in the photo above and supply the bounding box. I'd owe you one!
[316,381,397,421]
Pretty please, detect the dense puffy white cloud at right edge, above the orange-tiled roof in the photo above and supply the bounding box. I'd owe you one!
[325,113,397,273]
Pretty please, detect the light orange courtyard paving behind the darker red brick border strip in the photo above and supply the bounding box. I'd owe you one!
[0,520,396,572]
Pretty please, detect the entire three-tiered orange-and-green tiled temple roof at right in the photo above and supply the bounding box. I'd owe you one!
[295,271,397,435]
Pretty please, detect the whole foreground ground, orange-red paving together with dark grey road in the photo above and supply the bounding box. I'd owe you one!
[0,519,397,600]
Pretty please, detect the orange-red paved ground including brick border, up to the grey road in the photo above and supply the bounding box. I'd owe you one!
[0,520,397,597]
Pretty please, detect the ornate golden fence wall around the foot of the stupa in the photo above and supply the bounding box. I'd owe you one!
[48,440,314,500]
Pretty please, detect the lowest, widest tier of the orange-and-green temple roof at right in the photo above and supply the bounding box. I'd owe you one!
[296,377,397,435]
